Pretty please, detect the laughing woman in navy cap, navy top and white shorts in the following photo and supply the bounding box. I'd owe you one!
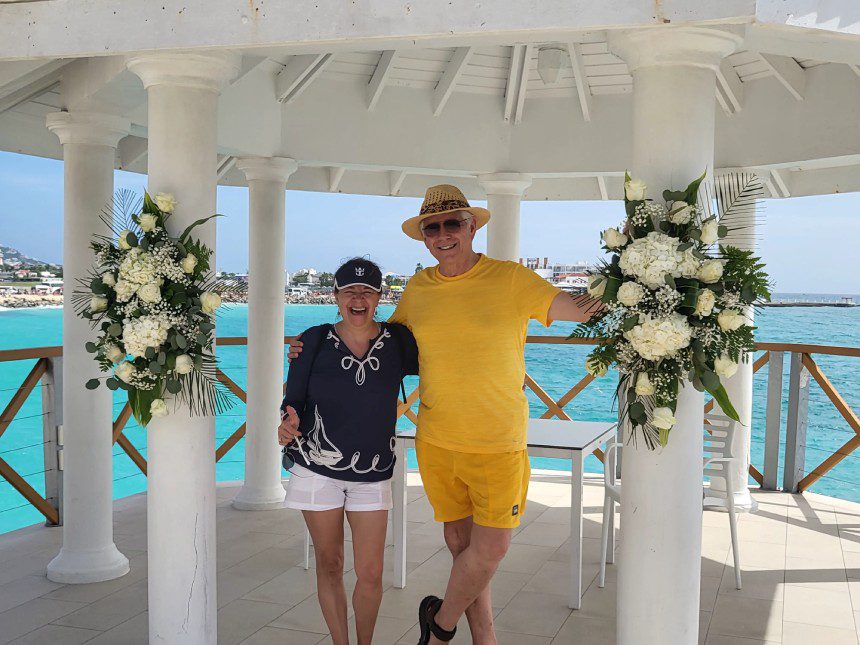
[278,258,418,645]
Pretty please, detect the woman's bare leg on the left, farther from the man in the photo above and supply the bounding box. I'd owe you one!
[302,508,349,645]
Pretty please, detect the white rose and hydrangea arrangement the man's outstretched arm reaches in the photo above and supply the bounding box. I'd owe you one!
[572,174,770,449]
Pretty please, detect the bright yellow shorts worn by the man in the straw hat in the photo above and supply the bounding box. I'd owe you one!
[415,441,531,529]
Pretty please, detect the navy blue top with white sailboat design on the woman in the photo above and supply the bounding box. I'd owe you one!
[281,323,418,482]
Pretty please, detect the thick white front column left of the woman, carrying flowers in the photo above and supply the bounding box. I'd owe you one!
[128,52,239,645]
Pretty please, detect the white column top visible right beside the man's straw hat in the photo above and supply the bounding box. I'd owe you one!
[478,172,532,262]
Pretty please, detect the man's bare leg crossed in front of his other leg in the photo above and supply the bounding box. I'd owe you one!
[430,524,512,645]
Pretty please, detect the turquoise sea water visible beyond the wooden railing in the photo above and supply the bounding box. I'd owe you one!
[0,302,860,533]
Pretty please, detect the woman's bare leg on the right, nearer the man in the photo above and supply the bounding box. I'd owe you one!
[346,511,388,645]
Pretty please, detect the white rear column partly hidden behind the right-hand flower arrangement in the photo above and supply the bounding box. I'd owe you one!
[711,201,758,511]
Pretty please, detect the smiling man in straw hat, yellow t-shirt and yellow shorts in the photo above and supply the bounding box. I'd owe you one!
[391,185,588,645]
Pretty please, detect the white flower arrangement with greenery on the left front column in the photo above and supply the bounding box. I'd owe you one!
[73,190,233,427]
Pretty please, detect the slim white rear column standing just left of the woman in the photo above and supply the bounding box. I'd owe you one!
[233,157,297,511]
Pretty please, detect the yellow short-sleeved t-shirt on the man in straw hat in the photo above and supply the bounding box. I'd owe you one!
[391,255,560,453]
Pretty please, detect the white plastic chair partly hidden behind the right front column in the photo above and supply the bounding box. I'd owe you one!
[597,414,741,589]
